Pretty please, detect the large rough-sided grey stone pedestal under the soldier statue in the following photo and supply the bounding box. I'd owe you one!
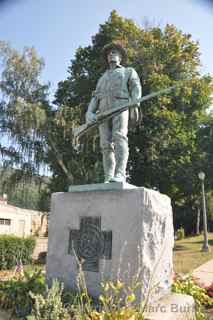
[47,183,173,300]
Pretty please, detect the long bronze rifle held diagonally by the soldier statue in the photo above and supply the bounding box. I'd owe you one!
[73,85,176,145]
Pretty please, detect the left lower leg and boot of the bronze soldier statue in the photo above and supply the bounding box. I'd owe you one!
[102,149,115,183]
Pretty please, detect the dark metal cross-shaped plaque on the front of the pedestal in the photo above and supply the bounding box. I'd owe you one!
[68,217,112,272]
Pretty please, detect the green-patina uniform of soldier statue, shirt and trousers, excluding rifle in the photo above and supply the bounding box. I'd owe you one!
[88,65,141,181]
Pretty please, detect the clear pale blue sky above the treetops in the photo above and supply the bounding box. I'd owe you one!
[0,0,213,100]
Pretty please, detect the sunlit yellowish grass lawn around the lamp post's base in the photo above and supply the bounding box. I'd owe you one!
[173,233,213,273]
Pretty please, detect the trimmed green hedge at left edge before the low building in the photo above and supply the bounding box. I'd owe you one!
[0,235,36,270]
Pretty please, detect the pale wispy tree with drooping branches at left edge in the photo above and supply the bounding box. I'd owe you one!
[0,41,88,205]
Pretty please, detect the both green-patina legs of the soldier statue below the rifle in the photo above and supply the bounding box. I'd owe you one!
[99,110,129,181]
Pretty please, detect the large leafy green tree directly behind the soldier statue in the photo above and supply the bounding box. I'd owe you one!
[52,11,212,231]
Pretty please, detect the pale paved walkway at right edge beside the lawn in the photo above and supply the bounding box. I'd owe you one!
[192,260,213,286]
